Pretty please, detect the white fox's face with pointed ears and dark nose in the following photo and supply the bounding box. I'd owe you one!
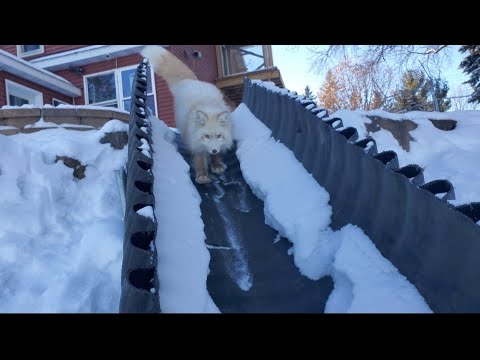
[196,111,232,154]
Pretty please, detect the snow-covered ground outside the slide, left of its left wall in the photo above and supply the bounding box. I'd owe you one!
[0,120,128,313]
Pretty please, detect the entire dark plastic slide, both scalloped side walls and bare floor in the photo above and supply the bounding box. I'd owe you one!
[119,60,480,313]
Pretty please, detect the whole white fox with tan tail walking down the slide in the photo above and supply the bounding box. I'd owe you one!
[142,46,233,183]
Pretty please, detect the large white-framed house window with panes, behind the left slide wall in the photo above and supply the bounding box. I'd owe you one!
[85,66,157,115]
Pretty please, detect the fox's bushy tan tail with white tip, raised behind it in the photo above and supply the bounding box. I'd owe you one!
[141,45,197,87]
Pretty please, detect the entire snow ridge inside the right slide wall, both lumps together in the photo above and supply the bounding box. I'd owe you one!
[232,104,430,312]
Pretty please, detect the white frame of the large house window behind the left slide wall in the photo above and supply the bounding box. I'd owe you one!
[83,65,158,116]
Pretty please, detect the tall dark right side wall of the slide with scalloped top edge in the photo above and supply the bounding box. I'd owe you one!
[242,79,480,313]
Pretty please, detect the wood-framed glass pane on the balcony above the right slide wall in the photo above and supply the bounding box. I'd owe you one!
[222,45,268,76]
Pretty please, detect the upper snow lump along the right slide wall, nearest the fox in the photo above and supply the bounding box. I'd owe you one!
[233,104,337,280]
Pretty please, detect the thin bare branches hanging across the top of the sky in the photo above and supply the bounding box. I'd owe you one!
[308,45,451,73]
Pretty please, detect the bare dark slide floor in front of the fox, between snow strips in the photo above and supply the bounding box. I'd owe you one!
[177,137,333,313]
